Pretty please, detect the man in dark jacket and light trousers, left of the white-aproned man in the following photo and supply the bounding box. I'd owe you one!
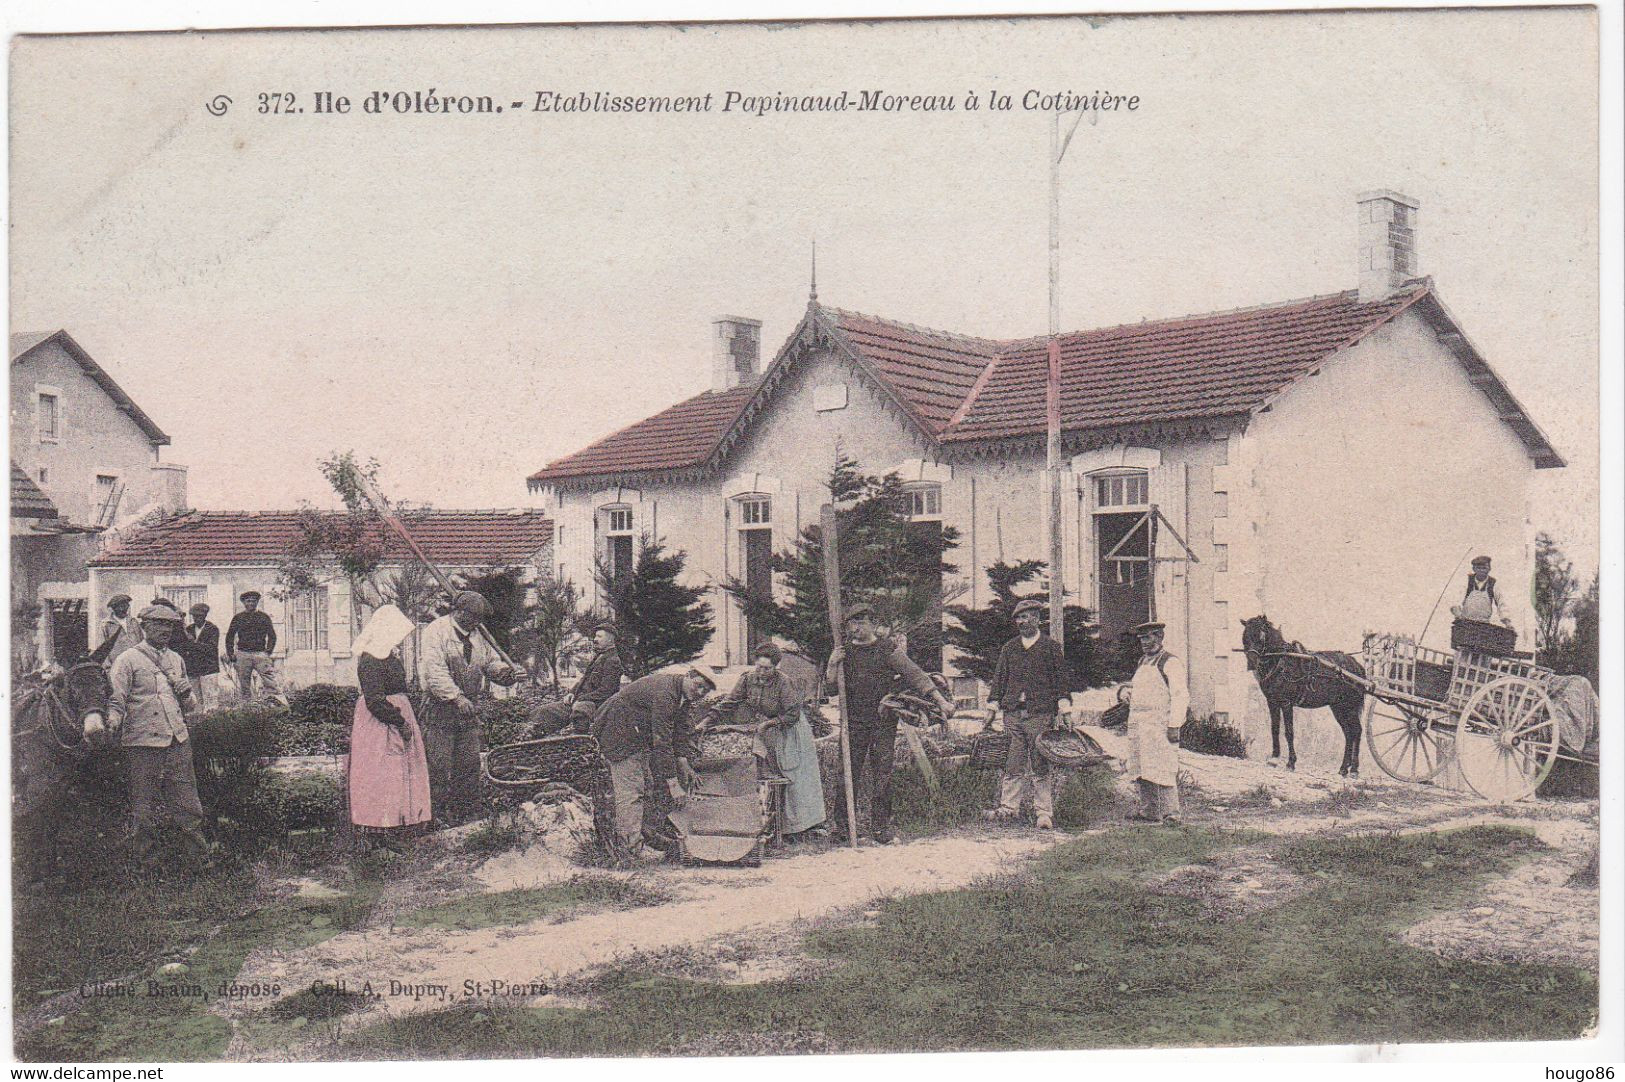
[986,598,1073,830]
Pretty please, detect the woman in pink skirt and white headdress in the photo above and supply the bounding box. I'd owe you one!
[349,604,431,851]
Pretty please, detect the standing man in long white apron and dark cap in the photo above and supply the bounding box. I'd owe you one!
[1128,622,1191,824]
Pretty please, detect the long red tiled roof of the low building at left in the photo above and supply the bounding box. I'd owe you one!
[91,510,553,567]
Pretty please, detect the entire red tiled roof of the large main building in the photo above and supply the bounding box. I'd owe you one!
[530,279,1563,484]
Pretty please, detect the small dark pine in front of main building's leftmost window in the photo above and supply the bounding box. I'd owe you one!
[596,536,715,676]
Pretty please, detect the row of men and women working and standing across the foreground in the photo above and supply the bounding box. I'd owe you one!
[104,568,1188,861]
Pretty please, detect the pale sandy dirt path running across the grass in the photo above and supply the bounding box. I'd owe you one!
[209,749,1597,1056]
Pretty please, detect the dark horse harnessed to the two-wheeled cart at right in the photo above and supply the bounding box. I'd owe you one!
[1242,616,1365,778]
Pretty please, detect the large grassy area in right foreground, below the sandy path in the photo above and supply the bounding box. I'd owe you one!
[333,827,1597,1058]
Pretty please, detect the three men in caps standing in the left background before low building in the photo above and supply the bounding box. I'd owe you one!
[91,590,281,710]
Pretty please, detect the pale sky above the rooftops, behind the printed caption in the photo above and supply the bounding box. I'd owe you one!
[10,10,1599,569]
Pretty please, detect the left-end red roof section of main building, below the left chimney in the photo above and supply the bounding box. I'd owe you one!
[530,383,756,483]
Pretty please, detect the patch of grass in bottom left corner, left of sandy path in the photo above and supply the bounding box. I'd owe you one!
[13,868,382,1063]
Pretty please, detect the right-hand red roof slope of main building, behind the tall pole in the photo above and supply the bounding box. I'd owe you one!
[944,286,1427,440]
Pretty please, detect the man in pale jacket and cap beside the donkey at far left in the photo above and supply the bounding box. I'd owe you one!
[107,604,210,868]
